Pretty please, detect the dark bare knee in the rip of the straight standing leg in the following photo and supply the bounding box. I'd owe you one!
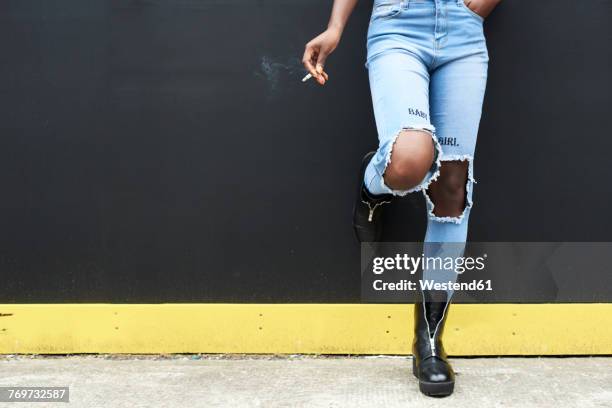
[427,160,469,217]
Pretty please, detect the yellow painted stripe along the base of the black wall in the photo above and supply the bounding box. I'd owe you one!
[0,303,612,355]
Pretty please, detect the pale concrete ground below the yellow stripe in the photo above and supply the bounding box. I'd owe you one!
[0,355,612,408]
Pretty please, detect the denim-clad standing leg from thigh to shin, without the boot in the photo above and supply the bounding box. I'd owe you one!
[423,46,488,294]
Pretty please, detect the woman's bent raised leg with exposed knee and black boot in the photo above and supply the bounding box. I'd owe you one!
[353,50,441,242]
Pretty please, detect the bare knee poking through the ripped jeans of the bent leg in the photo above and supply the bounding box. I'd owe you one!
[384,130,435,190]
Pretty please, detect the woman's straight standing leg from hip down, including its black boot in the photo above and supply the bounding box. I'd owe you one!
[413,0,488,396]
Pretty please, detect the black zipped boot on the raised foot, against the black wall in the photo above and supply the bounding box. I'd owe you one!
[353,152,393,242]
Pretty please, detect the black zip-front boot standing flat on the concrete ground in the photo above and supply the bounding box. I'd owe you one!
[412,291,455,397]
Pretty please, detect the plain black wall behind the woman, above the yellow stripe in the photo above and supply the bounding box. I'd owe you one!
[0,0,612,303]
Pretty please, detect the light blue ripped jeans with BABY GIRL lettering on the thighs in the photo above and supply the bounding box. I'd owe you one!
[364,0,489,294]
